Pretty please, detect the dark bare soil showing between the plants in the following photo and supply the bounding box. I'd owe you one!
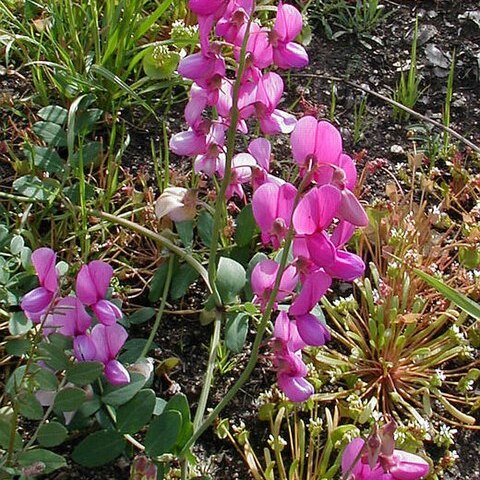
[0,0,480,480]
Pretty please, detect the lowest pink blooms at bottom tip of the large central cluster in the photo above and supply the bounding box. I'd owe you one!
[273,311,314,402]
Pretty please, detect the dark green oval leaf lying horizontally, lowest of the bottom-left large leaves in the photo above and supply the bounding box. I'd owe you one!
[72,430,125,468]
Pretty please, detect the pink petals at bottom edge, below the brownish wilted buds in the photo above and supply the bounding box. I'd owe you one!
[342,438,429,480]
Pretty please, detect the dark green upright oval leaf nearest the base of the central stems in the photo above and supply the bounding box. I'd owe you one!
[144,410,182,457]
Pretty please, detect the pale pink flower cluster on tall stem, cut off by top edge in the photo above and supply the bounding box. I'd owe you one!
[170,0,308,198]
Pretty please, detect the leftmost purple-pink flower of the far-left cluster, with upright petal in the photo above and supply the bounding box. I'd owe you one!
[20,247,58,323]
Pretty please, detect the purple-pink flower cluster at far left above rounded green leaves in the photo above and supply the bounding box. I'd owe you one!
[21,248,130,385]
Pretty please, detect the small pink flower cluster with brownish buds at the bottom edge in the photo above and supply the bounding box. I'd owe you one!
[342,421,430,480]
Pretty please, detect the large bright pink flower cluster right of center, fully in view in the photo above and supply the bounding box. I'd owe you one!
[252,117,368,402]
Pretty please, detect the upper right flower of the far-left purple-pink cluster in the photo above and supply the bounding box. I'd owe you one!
[76,260,122,325]
